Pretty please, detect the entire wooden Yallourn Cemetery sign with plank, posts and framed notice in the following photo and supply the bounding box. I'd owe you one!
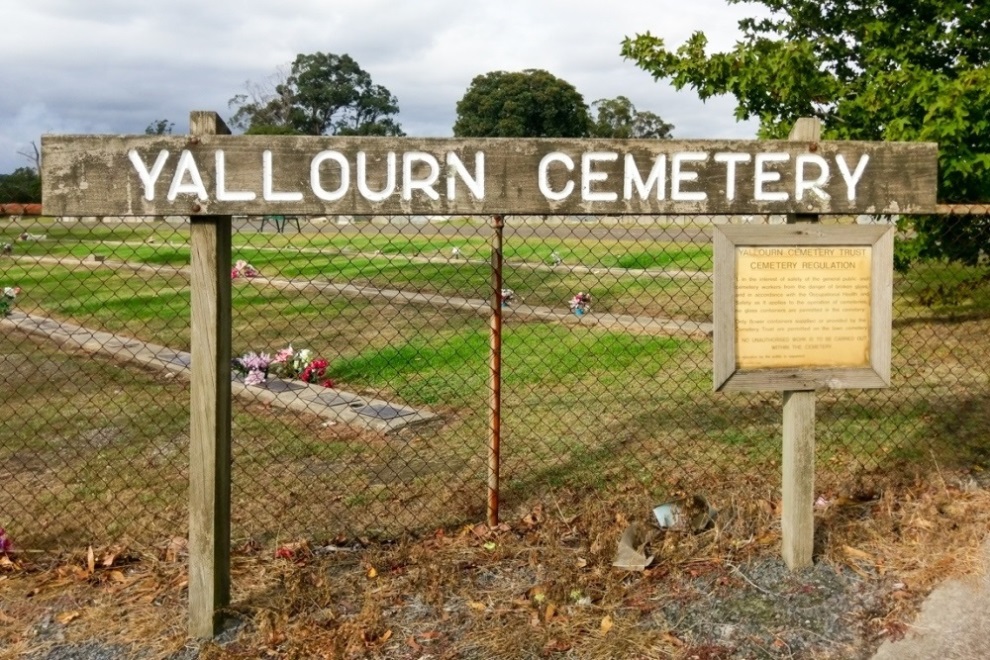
[41,112,937,637]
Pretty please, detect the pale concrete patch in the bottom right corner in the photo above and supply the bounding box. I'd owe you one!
[873,537,990,660]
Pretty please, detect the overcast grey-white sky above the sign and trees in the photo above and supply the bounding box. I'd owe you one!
[0,0,765,173]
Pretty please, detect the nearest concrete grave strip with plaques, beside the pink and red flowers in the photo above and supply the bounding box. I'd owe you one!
[0,311,436,433]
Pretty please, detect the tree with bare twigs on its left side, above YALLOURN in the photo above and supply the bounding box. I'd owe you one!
[229,53,403,135]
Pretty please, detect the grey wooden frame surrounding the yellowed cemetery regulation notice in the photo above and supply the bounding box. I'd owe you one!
[712,224,894,391]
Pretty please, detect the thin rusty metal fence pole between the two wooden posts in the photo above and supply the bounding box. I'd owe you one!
[487,215,505,527]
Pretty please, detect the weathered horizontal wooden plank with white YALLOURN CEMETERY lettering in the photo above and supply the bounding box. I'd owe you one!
[42,135,937,216]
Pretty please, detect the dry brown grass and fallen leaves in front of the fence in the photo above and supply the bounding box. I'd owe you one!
[0,465,990,658]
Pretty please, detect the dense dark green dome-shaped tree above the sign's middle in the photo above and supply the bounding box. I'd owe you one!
[454,69,591,137]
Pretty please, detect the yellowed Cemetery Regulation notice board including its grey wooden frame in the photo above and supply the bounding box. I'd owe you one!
[714,224,894,391]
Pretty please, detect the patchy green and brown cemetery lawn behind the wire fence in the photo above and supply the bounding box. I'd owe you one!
[0,215,990,543]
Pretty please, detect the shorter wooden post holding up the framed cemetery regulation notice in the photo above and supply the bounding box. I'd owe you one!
[780,117,821,571]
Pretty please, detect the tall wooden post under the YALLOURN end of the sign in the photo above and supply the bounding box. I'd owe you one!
[189,112,231,638]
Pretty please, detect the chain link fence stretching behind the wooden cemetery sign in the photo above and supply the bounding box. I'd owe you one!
[0,215,990,552]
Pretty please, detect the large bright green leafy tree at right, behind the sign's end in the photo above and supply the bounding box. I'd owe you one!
[622,0,990,263]
